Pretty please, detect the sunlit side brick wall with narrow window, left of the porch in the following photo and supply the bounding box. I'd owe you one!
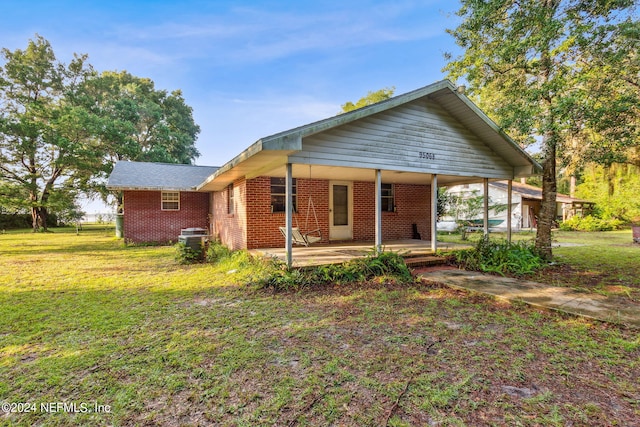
[211,179,248,250]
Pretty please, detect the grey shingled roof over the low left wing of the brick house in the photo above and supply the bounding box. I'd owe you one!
[107,161,218,191]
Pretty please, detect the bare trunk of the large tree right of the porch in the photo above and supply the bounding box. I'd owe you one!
[536,131,557,259]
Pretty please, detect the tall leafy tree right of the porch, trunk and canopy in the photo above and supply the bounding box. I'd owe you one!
[446,0,634,258]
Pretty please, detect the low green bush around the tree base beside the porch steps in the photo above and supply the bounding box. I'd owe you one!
[454,239,546,276]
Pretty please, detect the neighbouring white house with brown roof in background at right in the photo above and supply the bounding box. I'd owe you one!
[441,181,594,230]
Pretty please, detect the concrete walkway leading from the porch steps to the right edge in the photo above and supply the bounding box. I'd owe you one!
[420,270,640,329]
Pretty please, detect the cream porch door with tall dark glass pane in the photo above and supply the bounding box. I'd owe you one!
[329,181,353,240]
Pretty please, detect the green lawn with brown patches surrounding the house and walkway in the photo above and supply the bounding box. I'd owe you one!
[0,227,640,426]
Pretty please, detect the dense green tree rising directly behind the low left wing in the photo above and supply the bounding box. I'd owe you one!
[83,71,200,207]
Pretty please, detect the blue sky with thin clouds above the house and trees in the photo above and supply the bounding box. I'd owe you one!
[0,0,459,212]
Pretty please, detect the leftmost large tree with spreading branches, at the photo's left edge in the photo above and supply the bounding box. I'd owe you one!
[0,36,101,231]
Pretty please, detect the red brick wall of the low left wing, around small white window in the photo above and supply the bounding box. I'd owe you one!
[124,191,209,243]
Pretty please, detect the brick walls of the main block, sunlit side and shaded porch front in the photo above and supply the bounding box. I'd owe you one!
[212,177,431,249]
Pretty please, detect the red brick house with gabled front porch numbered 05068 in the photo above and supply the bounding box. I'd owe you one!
[108,80,541,258]
